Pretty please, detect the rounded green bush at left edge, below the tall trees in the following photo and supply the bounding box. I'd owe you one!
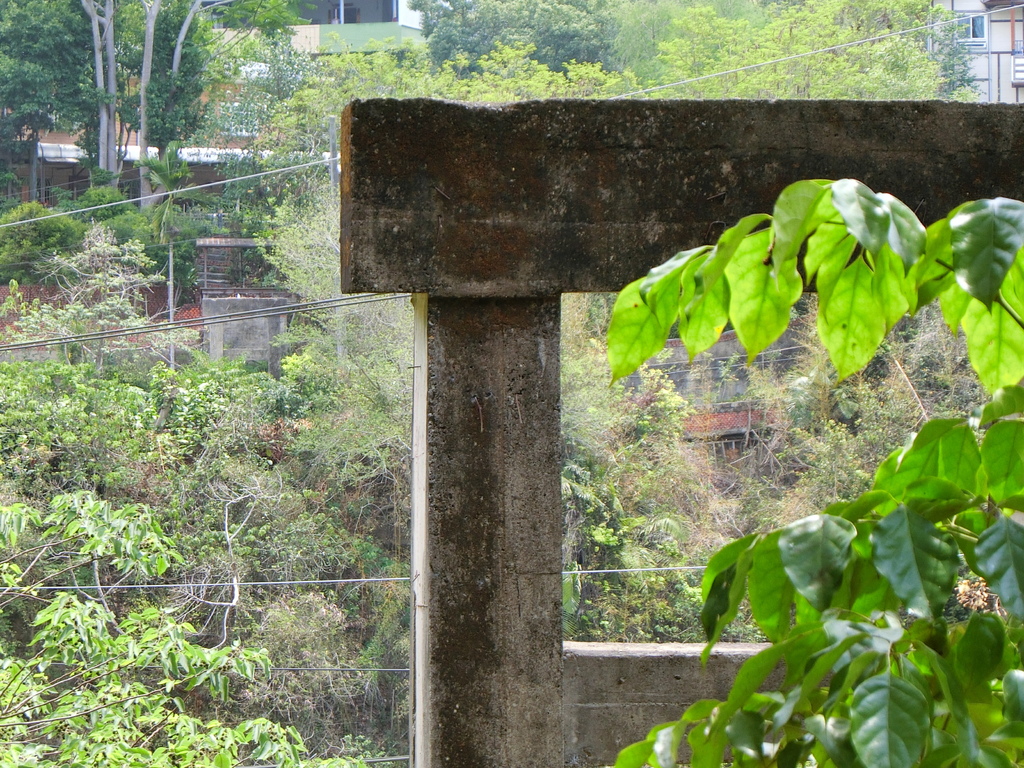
[0,203,85,285]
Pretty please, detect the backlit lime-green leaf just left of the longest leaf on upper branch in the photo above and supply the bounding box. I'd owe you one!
[725,230,803,362]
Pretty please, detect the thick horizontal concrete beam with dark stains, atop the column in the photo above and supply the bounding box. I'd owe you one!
[342,100,1024,296]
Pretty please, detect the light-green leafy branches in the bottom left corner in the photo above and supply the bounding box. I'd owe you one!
[0,495,327,768]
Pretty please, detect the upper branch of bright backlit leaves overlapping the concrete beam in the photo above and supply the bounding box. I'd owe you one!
[608,179,1024,390]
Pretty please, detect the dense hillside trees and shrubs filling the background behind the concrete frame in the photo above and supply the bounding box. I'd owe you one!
[0,0,995,768]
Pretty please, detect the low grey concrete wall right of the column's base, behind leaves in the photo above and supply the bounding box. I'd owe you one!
[563,643,767,766]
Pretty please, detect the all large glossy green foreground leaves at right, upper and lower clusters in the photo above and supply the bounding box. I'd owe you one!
[608,179,1024,768]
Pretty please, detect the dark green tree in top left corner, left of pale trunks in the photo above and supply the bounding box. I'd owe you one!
[0,0,89,200]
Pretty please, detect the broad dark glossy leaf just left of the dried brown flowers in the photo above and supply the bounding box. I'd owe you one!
[871,506,959,616]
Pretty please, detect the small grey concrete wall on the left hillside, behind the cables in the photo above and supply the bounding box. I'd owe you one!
[203,297,292,376]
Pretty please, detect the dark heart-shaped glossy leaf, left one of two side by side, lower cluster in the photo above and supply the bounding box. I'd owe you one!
[779,515,857,610]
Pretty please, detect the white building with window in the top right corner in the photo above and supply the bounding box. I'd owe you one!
[932,0,1024,103]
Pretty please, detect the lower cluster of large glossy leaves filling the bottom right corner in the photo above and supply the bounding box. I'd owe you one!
[616,387,1024,767]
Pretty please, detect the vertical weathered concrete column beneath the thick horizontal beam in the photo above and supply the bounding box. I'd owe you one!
[414,296,562,768]
